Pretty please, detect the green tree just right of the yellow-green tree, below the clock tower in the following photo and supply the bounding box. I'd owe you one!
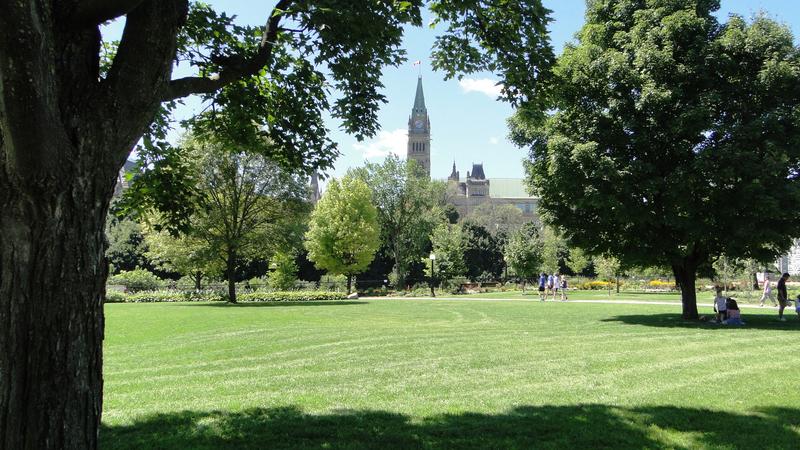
[350,155,445,287]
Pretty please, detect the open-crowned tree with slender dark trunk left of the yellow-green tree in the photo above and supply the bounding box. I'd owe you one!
[187,138,309,303]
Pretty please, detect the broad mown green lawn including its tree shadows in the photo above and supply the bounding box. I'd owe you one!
[100,300,800,449]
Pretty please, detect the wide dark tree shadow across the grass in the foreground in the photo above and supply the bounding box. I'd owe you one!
[100,405,800,450]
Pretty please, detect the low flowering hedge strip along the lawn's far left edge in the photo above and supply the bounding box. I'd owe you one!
[106,291,347,303]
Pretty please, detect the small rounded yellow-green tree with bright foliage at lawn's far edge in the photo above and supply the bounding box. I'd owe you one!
[305,176,381,294]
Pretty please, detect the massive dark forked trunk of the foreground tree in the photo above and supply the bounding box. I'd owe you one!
[0,0,194,450]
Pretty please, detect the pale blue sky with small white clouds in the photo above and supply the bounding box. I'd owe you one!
[106,0,800,178]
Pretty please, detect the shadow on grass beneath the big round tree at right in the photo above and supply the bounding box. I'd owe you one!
[602,313,800,331]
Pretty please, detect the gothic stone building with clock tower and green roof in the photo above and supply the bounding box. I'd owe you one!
[406,77,536,219]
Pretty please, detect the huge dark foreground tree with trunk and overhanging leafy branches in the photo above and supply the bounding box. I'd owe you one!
[0,0,553,442]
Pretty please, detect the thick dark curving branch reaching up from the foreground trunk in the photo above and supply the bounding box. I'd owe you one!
[164,0,292,101]
